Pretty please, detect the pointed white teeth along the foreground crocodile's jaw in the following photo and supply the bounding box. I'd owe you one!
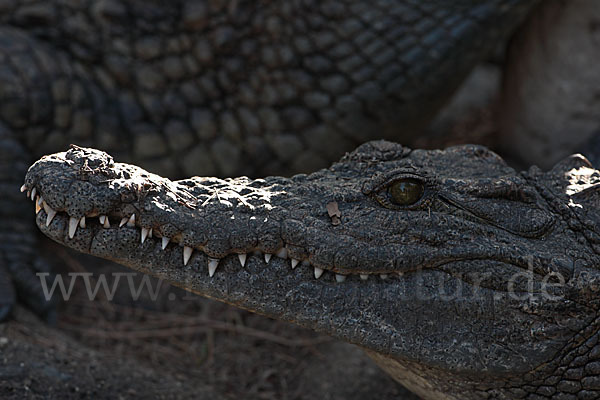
[21,185,396,283]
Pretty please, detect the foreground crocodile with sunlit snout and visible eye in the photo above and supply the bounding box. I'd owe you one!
[21,141,600,400]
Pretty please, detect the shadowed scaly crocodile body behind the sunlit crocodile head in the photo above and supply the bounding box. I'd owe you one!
[0,0,539,320]
